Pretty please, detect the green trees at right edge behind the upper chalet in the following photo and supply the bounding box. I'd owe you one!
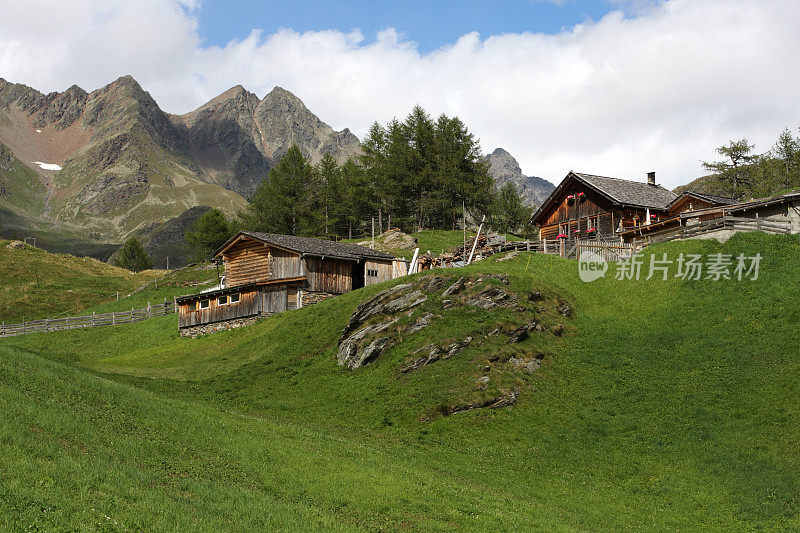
[702,128,800,199]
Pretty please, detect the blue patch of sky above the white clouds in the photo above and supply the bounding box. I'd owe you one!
[197,0,619,53]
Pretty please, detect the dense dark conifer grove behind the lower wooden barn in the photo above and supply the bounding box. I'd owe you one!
[186,106,532,259]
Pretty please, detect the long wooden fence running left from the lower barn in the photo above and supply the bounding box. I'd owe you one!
[0,300,175,337]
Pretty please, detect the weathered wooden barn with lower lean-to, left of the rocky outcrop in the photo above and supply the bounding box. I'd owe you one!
[177,231,405,335]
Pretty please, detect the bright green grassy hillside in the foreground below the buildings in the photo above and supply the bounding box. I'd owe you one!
[0,234,800,530]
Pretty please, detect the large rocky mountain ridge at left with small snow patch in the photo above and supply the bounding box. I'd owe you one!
[0,76,360,242]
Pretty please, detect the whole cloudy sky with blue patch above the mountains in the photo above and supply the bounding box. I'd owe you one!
[0,0,800,187]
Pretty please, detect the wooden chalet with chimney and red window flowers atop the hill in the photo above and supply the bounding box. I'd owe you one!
[530,172,677,241]
